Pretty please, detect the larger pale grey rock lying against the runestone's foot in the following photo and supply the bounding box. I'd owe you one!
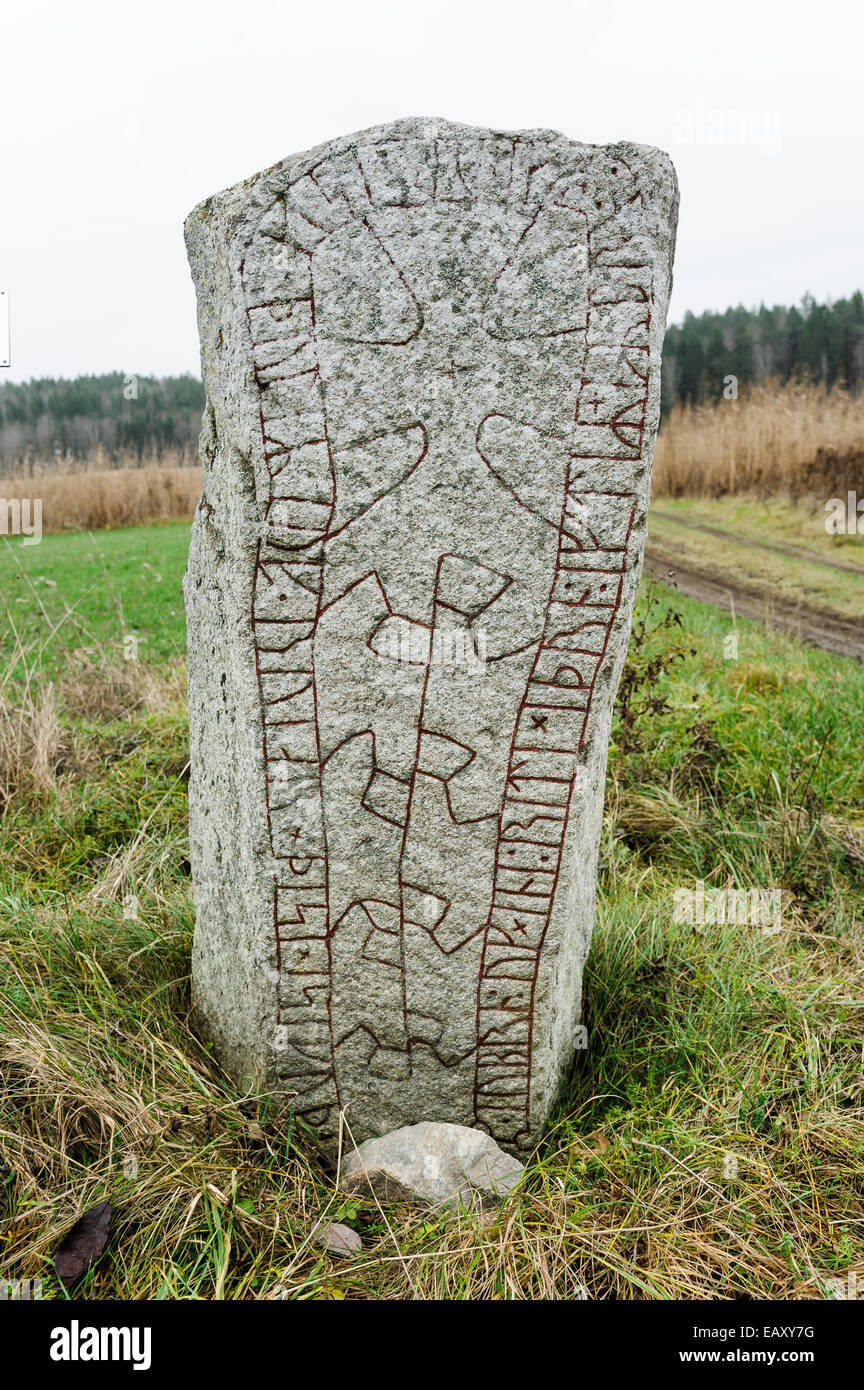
[342,1122,524,1207]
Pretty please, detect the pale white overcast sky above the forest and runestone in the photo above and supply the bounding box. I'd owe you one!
[0,0,864,381]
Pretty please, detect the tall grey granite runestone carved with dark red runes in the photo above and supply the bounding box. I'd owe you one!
[188,121,675,1150]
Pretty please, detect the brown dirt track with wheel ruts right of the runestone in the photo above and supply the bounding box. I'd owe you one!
[645,544,864,663]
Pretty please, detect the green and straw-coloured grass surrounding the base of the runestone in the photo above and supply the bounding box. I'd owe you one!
[0,524,864,1300]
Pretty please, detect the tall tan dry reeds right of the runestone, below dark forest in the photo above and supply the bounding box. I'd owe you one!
[654,381,864,498]
